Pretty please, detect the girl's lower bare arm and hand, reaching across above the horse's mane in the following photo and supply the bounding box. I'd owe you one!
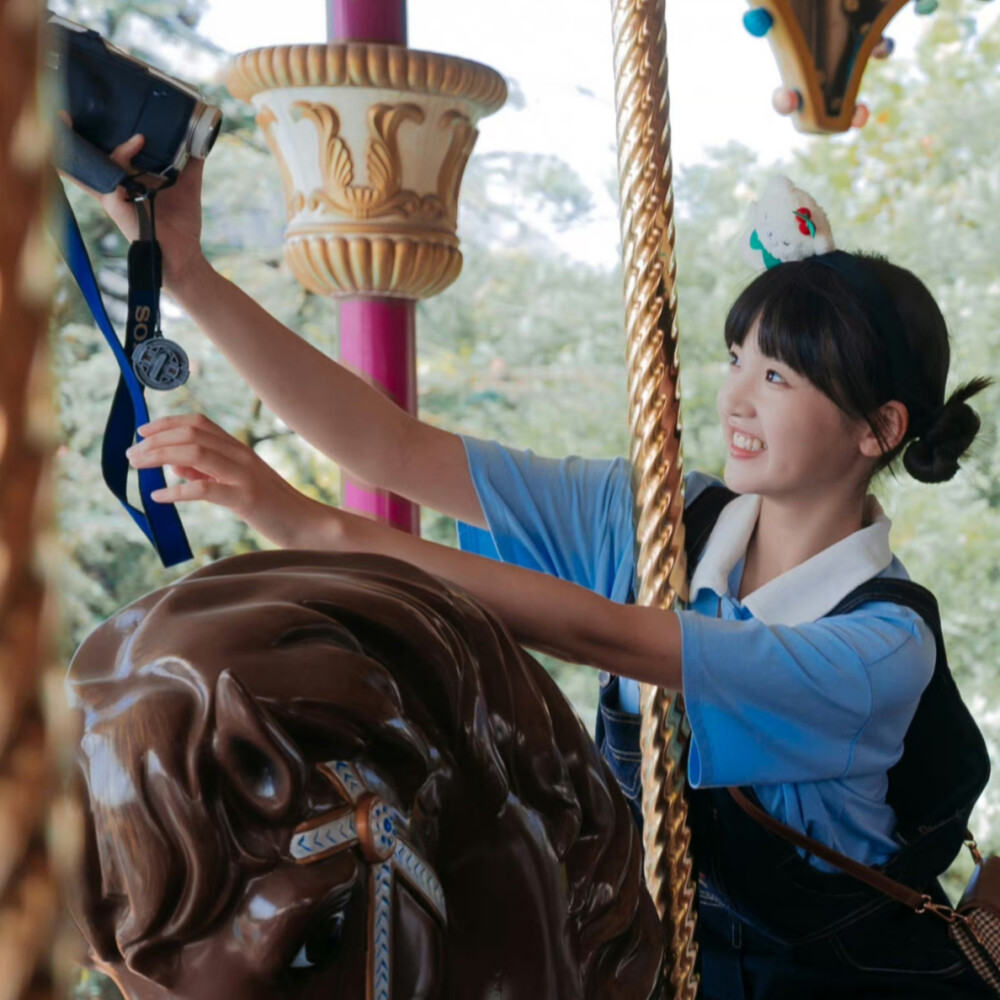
[130,417,680,686]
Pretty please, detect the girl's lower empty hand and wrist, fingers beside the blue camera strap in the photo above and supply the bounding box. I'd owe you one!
[126,414,336,549]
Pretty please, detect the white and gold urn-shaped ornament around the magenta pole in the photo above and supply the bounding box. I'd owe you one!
[226,42,507,299]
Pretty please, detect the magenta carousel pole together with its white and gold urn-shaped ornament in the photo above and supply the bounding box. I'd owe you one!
[227,9,507,533]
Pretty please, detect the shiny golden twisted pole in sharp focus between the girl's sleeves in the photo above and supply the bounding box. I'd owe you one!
[612,0,698,1000]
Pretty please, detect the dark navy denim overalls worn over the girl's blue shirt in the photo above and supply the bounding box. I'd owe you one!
[596,487,992,1000]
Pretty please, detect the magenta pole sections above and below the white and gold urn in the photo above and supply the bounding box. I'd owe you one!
[327,0,420,534]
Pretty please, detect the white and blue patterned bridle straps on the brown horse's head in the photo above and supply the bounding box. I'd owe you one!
[288,760,447,1000]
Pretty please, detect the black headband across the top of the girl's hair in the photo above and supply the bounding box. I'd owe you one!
[807,250,934,437]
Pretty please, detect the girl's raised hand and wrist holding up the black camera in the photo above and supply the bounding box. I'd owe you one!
[60,112,207,290]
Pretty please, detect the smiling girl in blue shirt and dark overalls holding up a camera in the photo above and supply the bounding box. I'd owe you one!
[84,138,988,1000]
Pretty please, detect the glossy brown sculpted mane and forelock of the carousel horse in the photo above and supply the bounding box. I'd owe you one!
[68,551,662,996]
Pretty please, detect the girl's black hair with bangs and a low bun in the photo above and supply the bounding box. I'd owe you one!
[726,253,992,483]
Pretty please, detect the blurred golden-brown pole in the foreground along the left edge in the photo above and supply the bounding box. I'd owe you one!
[0,0,57,1000]
